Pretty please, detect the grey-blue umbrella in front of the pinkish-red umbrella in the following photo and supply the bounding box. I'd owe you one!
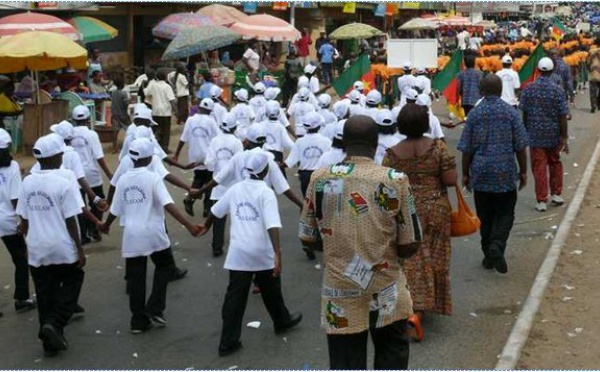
[162,25,242,60]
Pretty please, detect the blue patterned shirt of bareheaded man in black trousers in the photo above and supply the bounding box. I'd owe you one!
[458,96,528,193]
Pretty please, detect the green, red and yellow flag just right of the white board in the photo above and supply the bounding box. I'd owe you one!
[432,50,465,121]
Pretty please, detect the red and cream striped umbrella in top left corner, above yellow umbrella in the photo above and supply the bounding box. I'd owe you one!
[0,12,81,40]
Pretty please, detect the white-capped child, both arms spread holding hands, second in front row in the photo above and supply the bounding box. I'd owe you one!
[102,138,200,334]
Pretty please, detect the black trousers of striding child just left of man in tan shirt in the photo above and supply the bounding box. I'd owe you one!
[219,270,290,349]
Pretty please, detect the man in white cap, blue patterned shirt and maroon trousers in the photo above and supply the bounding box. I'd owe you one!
[520,57,569,212]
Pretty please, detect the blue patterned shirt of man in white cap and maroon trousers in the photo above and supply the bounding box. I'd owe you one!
[519,76,569,148]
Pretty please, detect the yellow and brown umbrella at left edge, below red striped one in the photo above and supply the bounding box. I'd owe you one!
[0,31,87,74]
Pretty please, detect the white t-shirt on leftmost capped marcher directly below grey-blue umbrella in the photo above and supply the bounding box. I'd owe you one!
[181,114,221,170]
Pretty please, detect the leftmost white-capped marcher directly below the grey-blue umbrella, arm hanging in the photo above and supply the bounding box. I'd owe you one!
[173,98,220,216]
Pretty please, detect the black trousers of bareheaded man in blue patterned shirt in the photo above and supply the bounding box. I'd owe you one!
[474,190,517,259]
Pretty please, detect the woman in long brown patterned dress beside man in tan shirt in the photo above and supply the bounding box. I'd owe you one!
[383,104,457,341]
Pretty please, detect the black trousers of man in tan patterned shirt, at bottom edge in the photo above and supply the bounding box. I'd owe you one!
[327,320,410,370]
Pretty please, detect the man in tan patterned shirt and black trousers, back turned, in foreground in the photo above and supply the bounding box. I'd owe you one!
[299,115,422,370]
